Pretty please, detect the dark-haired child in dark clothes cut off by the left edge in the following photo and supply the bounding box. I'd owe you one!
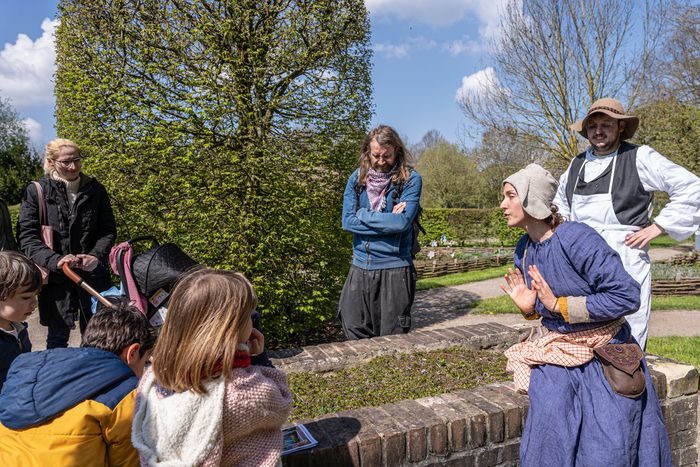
[0,251,41,389]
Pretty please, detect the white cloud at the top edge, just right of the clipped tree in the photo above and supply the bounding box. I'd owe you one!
[365,0,508,33]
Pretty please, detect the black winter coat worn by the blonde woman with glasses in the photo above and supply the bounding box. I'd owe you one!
[17,173,117,325]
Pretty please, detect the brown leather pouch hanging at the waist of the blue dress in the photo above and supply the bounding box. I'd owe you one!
[593,344,646,399]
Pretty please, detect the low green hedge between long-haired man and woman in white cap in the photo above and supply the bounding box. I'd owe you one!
[419,208,524,246]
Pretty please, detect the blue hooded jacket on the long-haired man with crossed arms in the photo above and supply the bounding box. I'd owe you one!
[343,169,423,269]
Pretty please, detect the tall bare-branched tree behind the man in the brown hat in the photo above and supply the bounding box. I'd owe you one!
[460,0,667,164]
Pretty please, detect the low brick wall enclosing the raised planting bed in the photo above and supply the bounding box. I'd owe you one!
[272,323,698,467]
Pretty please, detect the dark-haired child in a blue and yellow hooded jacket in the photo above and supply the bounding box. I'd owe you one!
[0,302,155,466]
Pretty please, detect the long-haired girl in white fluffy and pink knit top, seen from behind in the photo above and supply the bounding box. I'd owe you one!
[132,269,292,467]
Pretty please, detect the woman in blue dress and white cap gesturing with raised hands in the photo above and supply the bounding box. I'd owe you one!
[501,164,672,467]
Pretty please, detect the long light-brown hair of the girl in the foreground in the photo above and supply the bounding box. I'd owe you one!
[152,268,258,394]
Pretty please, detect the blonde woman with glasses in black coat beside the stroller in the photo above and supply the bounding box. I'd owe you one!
[17,139,117,349]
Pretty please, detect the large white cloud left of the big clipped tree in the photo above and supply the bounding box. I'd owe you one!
[0,18,58,107]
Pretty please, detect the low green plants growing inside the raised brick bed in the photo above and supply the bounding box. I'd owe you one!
[289,347,511,421]
